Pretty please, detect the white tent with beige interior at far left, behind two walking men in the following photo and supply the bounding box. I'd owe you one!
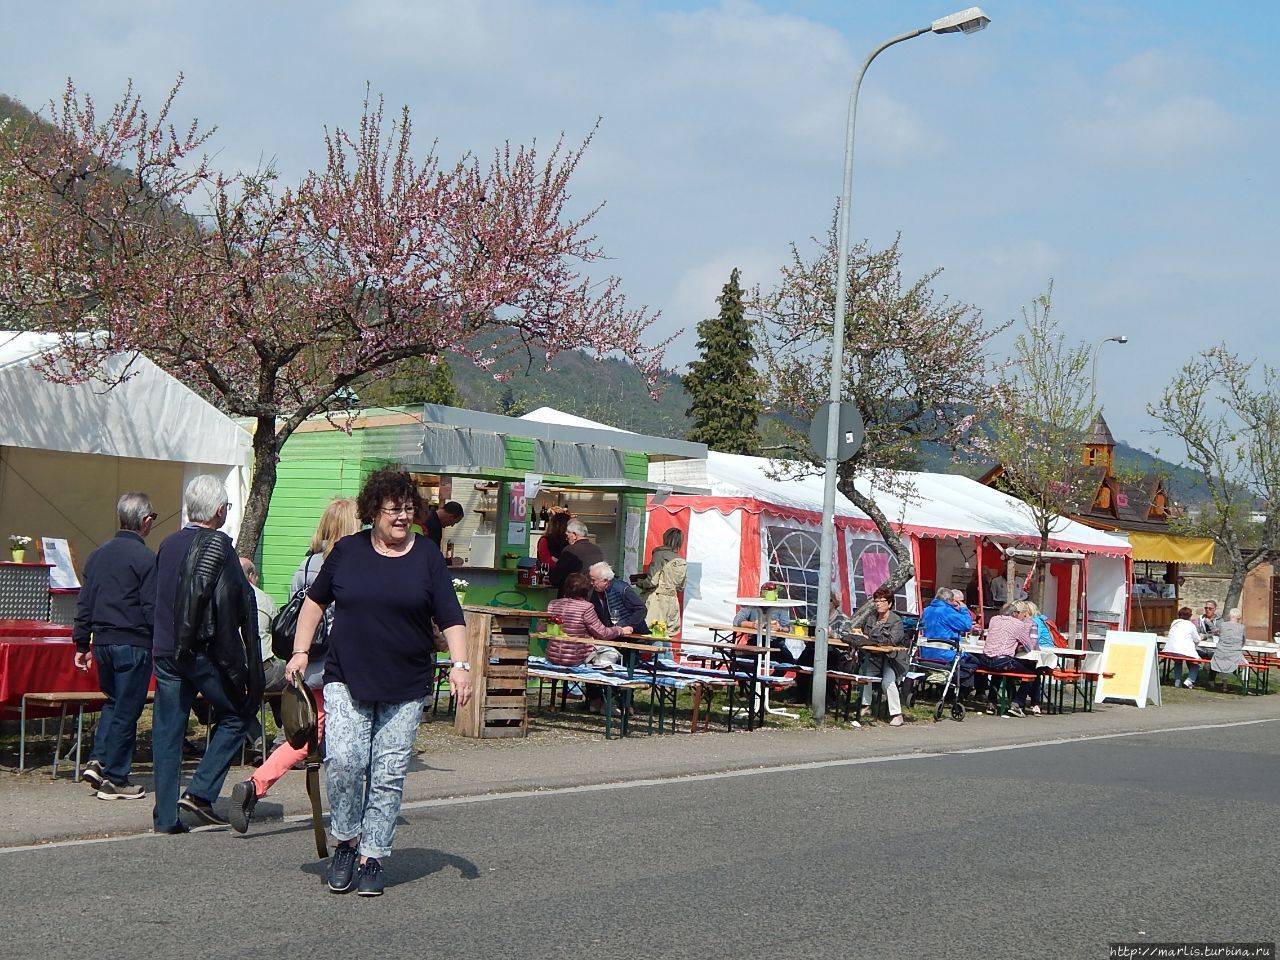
[0,332,251,563]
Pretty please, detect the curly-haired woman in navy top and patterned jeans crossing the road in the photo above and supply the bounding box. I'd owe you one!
[285,467,471,896]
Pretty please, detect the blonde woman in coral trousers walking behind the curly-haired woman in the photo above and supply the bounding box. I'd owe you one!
[230,497,360,833]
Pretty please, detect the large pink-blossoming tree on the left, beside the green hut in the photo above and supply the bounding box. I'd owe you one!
[0,78,664,554]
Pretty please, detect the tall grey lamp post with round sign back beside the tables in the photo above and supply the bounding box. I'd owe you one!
[813,6,991,724]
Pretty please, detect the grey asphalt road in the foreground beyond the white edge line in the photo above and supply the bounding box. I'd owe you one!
[0,723,1280,960]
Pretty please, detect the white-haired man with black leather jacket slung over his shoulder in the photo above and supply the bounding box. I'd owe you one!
[151,474,262,833]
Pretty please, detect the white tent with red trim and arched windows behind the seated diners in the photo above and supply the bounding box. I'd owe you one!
[645,452,1130,639]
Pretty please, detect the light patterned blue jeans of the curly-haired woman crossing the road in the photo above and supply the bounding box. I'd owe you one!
[324,684,426,859]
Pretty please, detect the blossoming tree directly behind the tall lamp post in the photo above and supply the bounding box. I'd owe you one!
[751,220,1002,622]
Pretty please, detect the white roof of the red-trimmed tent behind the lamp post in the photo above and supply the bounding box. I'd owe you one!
[649,451,1129,554]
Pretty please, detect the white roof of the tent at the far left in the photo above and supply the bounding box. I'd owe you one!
[0,330,252,466]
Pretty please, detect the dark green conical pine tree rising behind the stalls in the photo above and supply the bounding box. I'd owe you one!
[684,268,763,456]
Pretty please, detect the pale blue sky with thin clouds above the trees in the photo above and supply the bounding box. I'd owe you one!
[0,0,1280,460]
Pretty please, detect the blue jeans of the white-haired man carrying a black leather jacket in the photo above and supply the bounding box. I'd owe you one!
[151,654,261,831]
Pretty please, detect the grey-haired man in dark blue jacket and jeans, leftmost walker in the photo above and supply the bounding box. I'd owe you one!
[72,493,156,800]
